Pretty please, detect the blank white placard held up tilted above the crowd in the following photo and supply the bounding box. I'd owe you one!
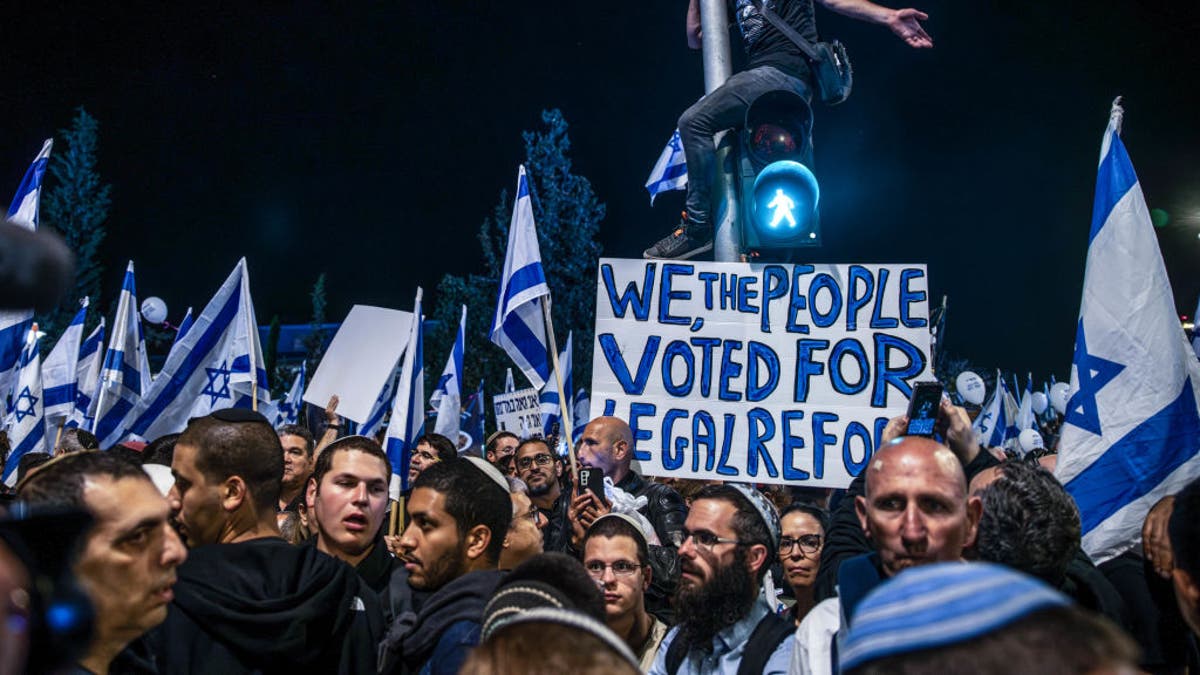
[304,305,413,424]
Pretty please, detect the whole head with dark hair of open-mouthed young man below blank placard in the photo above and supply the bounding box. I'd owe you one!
[306,436,391,565]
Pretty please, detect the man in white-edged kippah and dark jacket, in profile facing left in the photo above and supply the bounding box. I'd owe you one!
[380,458,512,675]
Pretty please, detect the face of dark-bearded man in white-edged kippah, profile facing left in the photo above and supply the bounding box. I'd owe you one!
[400,488,467,591]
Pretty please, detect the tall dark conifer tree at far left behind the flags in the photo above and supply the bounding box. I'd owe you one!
[41,107,112,338]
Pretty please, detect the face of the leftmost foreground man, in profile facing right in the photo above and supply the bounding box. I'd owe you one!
[76,476,187,637]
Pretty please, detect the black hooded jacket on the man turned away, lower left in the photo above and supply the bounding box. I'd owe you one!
[154,538,384,675]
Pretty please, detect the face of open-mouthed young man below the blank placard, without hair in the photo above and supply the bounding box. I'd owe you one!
[308,449,388,556]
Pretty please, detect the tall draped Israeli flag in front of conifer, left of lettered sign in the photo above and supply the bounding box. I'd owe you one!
[488,165,550,389]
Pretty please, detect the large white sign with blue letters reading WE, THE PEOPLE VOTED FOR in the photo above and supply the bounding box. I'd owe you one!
[590,258,932,486]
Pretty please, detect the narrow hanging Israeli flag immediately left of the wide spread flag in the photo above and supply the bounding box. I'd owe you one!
[92,261,154,448]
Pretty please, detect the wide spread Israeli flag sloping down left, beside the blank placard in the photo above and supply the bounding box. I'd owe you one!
[111,258,271,447]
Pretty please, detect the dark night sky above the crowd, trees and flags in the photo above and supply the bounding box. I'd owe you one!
[0,0,1200,380]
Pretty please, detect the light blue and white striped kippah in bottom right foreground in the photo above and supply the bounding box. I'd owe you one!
[838,562,1070,671]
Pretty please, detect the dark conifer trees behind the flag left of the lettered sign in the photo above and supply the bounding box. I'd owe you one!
[425,109,605,417]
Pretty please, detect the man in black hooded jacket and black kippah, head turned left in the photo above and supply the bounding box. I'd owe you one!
[155,408,384,674]
